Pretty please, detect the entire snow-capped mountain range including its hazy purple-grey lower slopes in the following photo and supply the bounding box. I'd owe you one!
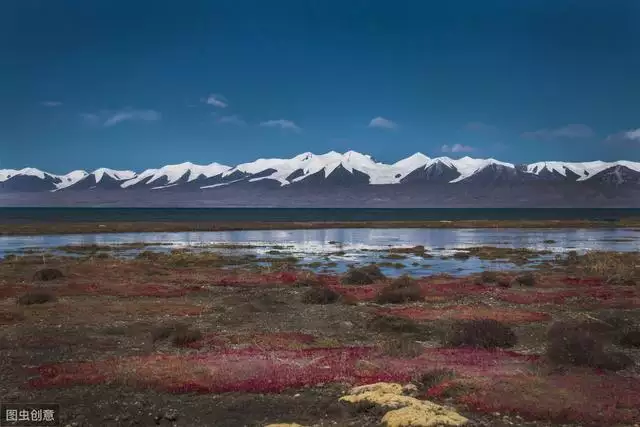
[0,151,640,207]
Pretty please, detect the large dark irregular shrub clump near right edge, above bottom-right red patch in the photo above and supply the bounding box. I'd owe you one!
[547,322,633,371]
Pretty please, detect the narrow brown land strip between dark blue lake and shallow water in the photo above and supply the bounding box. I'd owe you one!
[0,218,640,236]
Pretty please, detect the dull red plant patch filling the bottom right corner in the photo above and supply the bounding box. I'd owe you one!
[459,374,640,426]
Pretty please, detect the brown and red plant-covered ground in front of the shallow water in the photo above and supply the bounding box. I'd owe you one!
[0,251,640,427]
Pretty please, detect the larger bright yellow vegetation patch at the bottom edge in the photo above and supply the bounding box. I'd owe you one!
[340,383,469,427]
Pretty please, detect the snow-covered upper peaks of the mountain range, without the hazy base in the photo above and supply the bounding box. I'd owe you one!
[0,151,640,193]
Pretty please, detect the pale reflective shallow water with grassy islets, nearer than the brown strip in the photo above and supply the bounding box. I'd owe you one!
[0,228,640,276]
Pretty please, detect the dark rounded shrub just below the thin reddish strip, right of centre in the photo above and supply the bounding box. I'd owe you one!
[445,319,518,349]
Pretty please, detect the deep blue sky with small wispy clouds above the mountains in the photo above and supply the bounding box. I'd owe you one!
[0,0,640,173]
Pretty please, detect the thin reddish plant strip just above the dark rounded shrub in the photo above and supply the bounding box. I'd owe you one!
[379,306,551,323]
